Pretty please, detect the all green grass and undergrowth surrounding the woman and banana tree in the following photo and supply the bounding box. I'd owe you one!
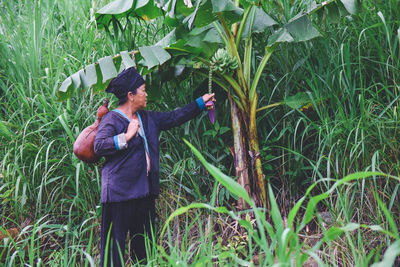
[0,0,400,266]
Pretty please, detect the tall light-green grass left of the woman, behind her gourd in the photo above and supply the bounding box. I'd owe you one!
[0,1,111,266]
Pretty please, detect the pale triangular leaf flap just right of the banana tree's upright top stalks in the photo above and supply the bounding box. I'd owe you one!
[242,6,278,38]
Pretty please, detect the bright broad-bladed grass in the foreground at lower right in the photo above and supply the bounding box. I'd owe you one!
[153,141,400,266]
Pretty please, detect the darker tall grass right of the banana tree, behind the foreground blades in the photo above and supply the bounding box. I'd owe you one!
[255,1,400,266]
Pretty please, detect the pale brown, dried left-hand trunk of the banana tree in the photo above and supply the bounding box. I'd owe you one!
[228,94,248,210]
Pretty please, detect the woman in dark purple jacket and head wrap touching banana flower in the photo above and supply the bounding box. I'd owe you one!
[94,67,215,266]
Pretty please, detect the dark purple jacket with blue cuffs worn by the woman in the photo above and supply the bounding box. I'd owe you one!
[94,98,204,203]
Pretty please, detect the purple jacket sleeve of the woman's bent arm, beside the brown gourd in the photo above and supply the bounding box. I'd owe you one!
[94,115,118,156]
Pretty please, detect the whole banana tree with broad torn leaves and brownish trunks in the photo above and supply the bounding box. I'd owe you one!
[60,0,358,208]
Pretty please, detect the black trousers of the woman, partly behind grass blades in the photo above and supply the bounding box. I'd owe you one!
[100,196,155,267]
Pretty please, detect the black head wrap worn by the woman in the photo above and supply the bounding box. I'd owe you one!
[106,67,144,99]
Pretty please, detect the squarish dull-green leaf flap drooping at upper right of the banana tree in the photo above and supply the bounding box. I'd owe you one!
[285,14,321,42]
